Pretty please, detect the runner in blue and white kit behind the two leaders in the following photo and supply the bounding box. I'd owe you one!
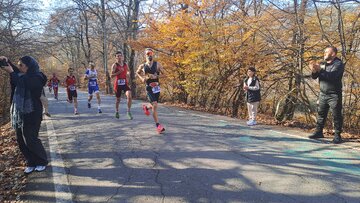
[85,62,102,113]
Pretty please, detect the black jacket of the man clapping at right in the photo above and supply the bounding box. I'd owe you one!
[312,58,344,94]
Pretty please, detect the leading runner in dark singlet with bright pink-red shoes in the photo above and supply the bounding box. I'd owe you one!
[136,48,165,133]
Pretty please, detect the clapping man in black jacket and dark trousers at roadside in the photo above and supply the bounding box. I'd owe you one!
[309,46,344,144]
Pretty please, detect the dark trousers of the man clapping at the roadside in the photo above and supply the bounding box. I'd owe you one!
[316,93,343,134]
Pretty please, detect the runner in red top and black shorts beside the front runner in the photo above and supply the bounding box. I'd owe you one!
[111,51,133,120]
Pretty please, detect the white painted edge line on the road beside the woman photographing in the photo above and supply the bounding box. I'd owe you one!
[45,119,73,203]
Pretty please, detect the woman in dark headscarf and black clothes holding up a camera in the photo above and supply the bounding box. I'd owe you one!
[0,56,48,173]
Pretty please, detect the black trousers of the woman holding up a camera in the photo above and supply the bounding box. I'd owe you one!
[16,113,48,167]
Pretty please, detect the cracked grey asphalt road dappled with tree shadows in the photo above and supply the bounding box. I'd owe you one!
[23,89,360,203]
